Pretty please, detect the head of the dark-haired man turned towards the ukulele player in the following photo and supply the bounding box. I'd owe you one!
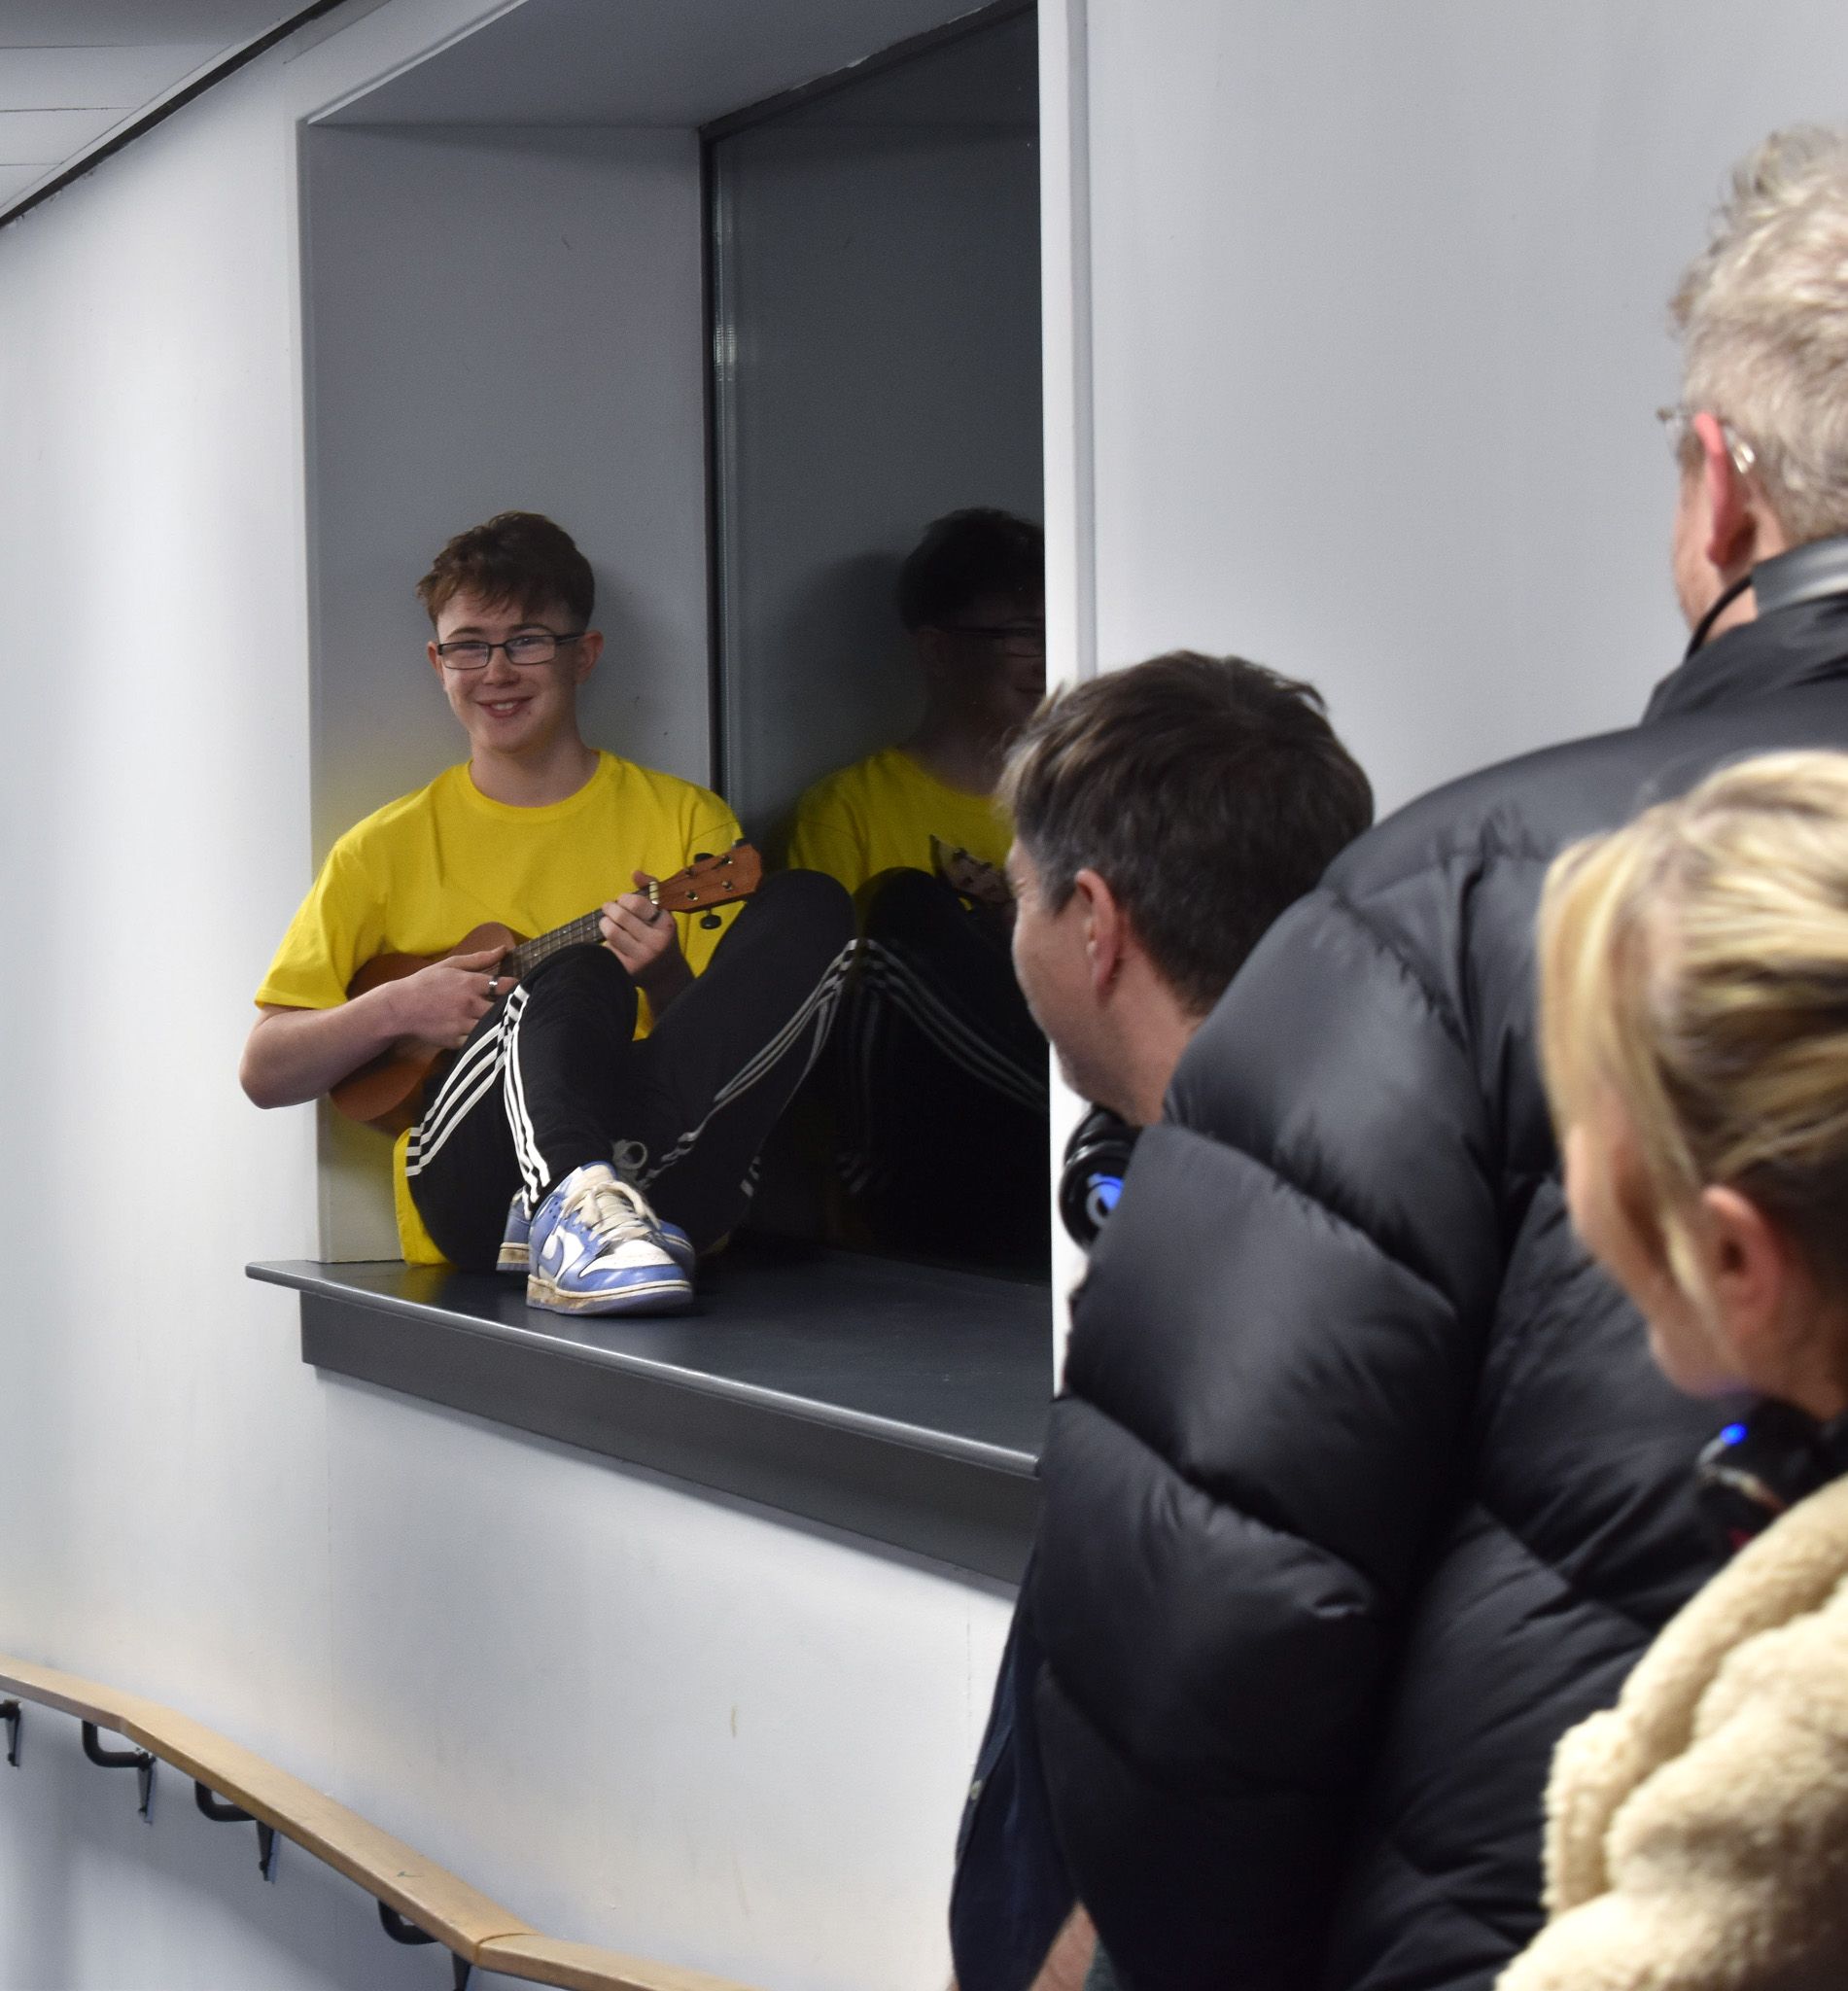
[997,651,1372,1127]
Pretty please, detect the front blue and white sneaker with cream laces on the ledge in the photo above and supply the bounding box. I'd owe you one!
[526,1161,693,1314]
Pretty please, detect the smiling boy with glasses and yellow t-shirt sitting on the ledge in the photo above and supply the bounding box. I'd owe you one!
[241,511,853,1314]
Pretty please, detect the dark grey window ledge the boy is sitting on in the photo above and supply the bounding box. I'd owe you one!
[249,1244,1052,1583]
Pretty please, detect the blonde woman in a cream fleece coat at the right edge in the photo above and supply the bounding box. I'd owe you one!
[1500,752,1848,1991]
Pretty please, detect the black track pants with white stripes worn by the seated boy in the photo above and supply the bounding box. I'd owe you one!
[408,872,853,1271]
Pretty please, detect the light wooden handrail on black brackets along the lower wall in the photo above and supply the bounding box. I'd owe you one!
[0,1655,743,1991]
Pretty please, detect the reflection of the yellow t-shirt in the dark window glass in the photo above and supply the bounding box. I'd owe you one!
[786,747,1014,892]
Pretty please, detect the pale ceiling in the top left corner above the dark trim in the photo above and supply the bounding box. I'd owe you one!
[0,0,302,217]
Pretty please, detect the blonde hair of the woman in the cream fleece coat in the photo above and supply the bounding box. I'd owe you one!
[1539,752,1848,1298]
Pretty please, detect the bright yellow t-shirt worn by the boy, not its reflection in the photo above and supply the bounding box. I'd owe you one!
[257,752,739,1264]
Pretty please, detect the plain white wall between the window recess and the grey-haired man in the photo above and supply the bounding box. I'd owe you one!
[1075,0,1848,806]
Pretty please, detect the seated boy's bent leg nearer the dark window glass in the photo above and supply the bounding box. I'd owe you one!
[615,872,854,1250]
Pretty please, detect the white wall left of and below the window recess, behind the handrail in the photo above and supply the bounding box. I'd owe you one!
[0,0,1005,1991]
